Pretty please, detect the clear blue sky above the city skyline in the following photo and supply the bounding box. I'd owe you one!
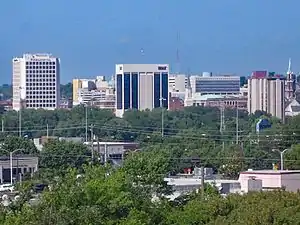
[0,0,300,84]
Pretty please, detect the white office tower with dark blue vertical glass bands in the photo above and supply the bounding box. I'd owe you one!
[115,64,169,117]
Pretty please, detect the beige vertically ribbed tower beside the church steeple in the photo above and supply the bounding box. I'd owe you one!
[248,71,285,120]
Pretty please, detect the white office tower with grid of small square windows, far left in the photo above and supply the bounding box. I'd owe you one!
[12,54,60,111]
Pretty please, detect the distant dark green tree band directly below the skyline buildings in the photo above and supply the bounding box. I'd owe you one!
[0,106,300,174]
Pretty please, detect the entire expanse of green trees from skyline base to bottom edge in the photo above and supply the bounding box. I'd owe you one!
[0,106,300,225]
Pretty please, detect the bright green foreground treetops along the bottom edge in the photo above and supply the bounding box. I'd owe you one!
[0,166,300,225]
